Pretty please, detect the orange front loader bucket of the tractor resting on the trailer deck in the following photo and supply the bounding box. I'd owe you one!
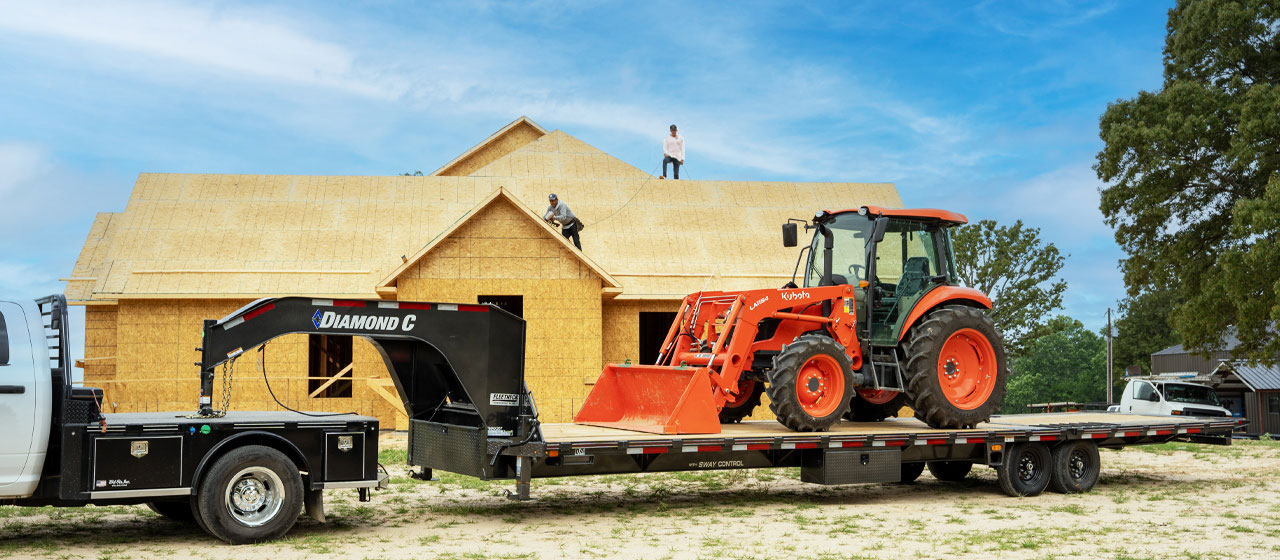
[573,363,721,433]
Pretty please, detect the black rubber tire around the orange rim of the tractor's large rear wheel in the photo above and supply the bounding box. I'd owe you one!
[905,306,1009,428]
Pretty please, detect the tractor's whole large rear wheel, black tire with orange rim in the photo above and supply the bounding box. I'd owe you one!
[905,306,1009,428]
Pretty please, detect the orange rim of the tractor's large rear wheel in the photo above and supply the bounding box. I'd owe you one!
[938,329,997,410]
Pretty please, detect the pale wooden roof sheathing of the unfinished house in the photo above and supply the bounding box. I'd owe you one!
[67,118,902,303]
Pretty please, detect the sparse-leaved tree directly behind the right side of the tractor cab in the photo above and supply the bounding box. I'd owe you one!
[951,220,1066,354]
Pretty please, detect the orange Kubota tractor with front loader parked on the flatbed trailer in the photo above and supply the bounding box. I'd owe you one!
[573,206,1009,433]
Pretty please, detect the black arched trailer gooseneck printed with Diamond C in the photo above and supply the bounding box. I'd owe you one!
[198,297,524,436]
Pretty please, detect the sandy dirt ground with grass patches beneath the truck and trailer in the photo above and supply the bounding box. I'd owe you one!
[0,435,1280,560]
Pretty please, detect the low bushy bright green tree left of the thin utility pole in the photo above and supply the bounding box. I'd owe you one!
[1000,316,1107,413]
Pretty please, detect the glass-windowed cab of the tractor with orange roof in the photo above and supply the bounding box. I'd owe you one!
[783,206,966,346]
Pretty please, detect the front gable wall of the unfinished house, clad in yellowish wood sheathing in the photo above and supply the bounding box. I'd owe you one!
[397,198,602,422]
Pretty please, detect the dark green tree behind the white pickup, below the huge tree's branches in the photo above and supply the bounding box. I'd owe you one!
[1102,292,1180,377]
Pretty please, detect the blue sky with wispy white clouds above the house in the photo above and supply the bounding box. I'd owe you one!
[0,0,1170,350]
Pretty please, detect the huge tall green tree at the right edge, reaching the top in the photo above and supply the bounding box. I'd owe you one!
[1094,0,1280,358]
